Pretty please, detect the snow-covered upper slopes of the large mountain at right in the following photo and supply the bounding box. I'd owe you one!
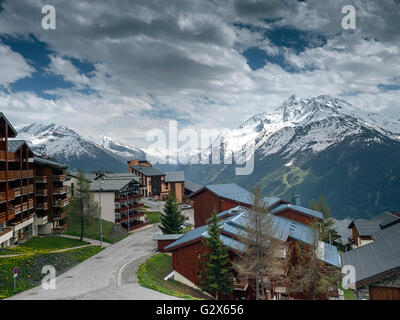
[203,95,400,163]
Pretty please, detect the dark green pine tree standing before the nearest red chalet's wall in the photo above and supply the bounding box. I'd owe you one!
[200,210,233,300]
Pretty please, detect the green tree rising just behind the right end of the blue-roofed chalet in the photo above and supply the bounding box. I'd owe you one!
[310,196,340,244]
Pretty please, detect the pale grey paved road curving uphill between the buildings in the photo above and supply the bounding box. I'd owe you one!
[10,226,177,300]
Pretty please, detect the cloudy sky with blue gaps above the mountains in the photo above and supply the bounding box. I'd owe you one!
[0,0,400,146]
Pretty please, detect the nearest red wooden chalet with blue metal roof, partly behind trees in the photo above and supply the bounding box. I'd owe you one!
[164,206,340,299]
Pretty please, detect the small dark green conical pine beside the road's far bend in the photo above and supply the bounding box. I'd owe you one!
[159,190,185,234]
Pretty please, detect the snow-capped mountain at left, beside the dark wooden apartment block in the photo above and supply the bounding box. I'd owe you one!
[17,123,127,172]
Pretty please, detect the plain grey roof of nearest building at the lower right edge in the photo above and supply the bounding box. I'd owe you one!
[341,223,400,283]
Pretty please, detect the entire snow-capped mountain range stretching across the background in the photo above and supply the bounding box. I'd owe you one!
[14,96,400,218]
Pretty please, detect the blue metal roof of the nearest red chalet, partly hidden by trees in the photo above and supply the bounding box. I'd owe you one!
[165,206,340,266]
